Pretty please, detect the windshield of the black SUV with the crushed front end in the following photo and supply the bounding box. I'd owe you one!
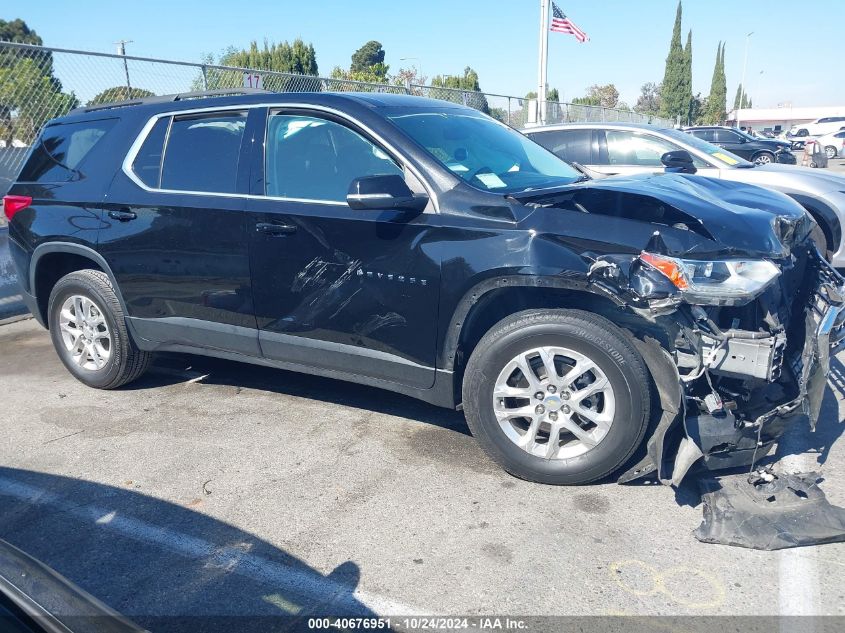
[388,110,583,193]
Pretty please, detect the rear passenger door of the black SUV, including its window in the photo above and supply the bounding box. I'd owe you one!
[99,110,258,354]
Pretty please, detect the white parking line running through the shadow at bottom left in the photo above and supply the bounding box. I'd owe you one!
[0,477,422,616]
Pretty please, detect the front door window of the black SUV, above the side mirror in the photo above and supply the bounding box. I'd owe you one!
[264,113,404,202]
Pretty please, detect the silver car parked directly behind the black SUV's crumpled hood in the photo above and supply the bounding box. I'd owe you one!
[524,123,845,268]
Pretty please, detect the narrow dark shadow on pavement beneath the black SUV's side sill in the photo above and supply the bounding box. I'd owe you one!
[121,354,470,435]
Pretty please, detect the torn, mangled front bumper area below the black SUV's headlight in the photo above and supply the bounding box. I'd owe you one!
[619,247,845,484]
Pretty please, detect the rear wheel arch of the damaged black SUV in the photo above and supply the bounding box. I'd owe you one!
[29,242,126,327]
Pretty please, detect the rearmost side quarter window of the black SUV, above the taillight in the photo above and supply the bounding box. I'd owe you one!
[18,119,117,183]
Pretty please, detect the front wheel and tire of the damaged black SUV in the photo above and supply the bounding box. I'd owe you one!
[463,310,651,485]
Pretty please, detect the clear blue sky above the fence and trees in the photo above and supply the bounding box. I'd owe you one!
[6,0,845,106]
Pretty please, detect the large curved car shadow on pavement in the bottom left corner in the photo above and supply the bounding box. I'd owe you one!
[0,467,388,632]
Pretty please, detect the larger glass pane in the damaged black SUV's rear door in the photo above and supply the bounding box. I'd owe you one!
[161,112,246,193]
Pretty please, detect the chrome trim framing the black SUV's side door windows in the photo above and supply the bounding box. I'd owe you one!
[121,101,440,213]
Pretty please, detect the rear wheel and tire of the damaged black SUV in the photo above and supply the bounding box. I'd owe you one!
[47,270,152,389]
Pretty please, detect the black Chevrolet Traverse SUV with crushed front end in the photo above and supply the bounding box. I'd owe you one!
[4,93,845,484]
